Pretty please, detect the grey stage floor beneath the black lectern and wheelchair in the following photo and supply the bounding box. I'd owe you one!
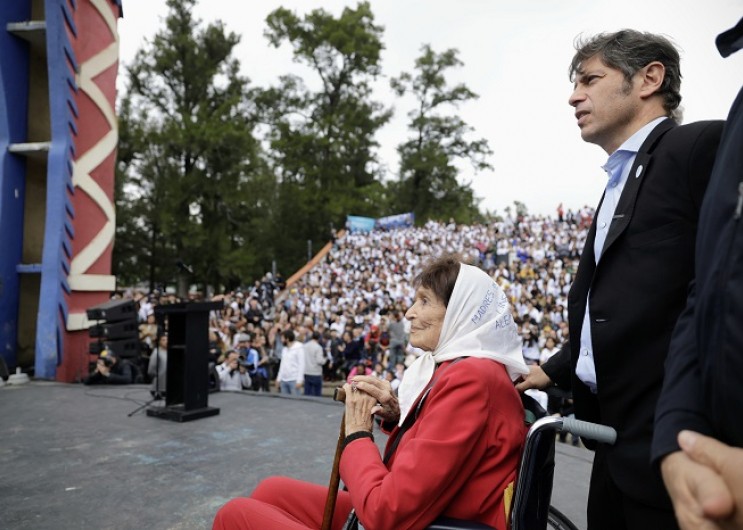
[0,382,592,530]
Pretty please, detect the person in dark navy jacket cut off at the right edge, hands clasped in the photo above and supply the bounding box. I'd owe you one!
[653,19,743,530]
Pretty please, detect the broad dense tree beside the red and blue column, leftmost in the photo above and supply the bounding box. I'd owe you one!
[117,0,274,287]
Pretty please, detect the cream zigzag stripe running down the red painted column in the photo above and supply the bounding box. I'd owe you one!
[67,0,119,331]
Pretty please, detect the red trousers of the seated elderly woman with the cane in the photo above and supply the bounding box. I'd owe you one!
[212,477,352,530]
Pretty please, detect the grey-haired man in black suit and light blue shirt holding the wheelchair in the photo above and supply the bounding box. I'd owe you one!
[517,30,722,530]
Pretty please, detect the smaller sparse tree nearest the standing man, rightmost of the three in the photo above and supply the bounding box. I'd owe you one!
[390,45,492,223]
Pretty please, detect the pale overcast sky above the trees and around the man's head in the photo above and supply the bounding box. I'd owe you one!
[119,0,743,214]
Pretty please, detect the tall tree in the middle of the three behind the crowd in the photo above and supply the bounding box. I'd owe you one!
[257,2,391,266]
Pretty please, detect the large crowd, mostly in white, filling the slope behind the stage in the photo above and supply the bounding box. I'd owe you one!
[91,205,592,420]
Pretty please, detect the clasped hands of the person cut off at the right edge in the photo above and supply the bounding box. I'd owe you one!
[661,431,743,530]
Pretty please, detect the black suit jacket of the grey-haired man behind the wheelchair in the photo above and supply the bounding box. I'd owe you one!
[543,120,723,506]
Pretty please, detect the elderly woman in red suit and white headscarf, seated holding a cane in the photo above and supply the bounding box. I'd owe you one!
[214,255,528,530]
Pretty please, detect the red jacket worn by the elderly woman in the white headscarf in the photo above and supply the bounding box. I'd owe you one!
[340,357,526,530]
